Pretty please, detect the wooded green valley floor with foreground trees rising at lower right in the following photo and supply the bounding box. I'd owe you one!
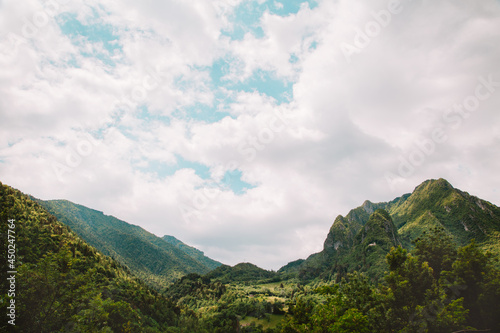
[160,224,500,333]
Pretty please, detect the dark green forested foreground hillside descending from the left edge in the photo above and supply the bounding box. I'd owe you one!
[0,183,179,333]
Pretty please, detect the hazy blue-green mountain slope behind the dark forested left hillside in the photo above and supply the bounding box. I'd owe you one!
[36,200,221,288]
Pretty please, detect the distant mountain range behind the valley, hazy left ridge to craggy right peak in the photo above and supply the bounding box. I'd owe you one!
[10,179,500,287]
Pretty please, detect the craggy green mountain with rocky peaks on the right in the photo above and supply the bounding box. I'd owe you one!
[288,179,500,279]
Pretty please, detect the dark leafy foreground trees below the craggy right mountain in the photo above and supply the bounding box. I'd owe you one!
[280,240,500,333]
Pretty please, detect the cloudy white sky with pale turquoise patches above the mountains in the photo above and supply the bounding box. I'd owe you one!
[0,0,500,270]
